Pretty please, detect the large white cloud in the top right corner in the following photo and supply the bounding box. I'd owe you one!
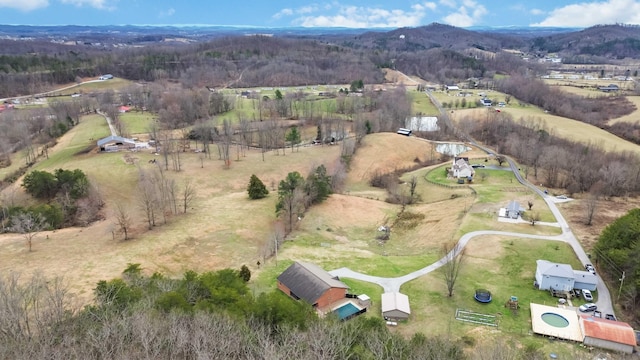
[531,0,640,27]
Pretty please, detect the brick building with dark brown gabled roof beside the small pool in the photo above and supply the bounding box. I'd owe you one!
[278,261,349,308]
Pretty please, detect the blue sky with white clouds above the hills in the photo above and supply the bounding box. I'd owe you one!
[0,0,640,28]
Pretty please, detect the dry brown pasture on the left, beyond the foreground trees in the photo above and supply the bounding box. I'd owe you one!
[0,123,340,301]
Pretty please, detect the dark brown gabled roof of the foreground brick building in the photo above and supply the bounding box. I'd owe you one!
[278,261,349,304]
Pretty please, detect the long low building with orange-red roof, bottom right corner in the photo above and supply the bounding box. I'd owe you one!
[580,315,636,354]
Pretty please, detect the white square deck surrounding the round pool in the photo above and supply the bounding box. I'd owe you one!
[529,303,584,342]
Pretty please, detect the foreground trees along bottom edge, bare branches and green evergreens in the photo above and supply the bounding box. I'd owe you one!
[0,264,596,360]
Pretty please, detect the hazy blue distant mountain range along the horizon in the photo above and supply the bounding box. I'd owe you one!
[0,23,640,59]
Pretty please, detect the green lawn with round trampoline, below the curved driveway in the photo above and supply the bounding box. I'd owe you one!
[400,236,583,335]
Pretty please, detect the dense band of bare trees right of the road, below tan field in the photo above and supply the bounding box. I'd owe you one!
[461,110,640,197]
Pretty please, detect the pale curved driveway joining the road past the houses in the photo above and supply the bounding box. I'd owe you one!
[330,153,614,314]
